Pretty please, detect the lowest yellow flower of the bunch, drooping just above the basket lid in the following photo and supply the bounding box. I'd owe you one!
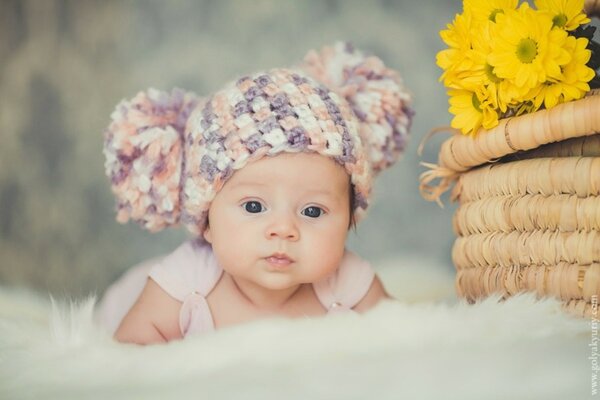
[448,89,498,136]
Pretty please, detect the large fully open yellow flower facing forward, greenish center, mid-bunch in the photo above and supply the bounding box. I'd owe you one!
[488,3,571,89]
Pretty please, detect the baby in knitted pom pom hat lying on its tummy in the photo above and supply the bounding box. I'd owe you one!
[103,43,412,344]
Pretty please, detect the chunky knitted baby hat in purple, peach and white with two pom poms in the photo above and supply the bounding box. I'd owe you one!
[104,43,413,236]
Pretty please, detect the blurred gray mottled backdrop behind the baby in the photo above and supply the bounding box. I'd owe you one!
[0,0,461,296]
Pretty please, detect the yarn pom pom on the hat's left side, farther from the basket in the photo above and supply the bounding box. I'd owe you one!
[104,89,199,232]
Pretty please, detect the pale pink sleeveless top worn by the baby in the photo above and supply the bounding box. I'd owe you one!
[98,240,375,337]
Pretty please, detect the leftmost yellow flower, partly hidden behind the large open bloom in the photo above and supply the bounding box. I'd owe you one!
[436,14,473,88]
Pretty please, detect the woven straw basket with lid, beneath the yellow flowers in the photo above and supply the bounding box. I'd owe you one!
[420,0,600,317]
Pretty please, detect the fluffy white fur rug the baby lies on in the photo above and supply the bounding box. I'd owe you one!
[0,262,592,400]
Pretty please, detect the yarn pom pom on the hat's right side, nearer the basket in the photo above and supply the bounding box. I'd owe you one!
[303,42,414,174]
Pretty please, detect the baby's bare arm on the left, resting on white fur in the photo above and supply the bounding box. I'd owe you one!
[114,278,182,344]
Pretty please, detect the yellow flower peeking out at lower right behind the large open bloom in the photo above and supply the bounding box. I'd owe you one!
[534,36,595,109]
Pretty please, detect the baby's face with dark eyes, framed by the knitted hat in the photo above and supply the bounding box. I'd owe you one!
[204,153,350,290]
